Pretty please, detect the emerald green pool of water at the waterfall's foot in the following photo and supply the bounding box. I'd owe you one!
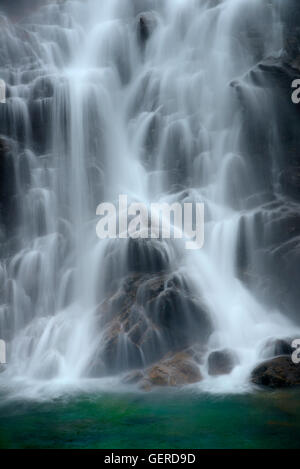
[0,391,300,449]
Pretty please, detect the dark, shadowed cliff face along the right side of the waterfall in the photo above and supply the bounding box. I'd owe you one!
[232,0,300,321]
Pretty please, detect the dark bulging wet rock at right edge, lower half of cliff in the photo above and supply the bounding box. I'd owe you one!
[237,200,300,322]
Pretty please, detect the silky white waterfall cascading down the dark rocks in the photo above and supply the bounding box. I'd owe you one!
[0,0,296,392]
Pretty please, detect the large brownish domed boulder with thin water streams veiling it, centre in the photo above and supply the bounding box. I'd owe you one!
[93,273,212,374]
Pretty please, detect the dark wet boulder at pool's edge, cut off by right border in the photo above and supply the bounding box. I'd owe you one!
[251,356,300,388]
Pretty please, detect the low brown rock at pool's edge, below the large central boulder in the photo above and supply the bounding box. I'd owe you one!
[125,351,202,390]
